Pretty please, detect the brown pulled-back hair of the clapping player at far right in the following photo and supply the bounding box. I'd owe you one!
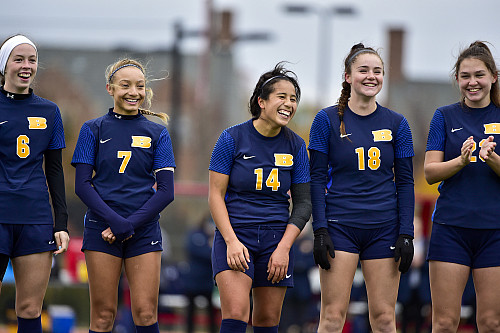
[453,41,500,107]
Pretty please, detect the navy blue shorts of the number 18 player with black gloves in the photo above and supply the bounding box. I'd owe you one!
[328,222,399,260]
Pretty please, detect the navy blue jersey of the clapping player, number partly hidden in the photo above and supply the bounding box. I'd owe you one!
[427,103,500,229]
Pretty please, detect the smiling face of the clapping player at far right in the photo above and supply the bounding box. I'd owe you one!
[457,58,497,108]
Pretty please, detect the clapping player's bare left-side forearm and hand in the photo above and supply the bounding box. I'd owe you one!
[424,136,474,184]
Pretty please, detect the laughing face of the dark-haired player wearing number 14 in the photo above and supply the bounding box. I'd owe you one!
[256,80,297,132]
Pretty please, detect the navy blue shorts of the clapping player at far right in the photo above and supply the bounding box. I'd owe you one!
[427,223,500,268]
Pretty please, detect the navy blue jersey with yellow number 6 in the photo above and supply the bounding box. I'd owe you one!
[0,94,66,224]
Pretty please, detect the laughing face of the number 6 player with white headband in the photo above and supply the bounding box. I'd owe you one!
[4,44,38,94]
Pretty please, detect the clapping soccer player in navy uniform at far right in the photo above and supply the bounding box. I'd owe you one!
[424,41,500,332]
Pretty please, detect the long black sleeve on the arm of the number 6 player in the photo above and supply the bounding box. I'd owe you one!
[44,149,68,232]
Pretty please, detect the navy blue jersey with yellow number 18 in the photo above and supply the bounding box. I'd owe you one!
[309,104,414,231]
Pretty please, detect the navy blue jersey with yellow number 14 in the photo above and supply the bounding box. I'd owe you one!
[209,120,310,226]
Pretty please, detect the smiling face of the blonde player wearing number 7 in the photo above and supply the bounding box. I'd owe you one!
[106,66,146,115]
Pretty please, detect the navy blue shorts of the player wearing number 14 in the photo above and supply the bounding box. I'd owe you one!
[212,222,294,288]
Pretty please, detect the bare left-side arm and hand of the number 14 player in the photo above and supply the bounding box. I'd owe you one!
[208,171,250,272]
